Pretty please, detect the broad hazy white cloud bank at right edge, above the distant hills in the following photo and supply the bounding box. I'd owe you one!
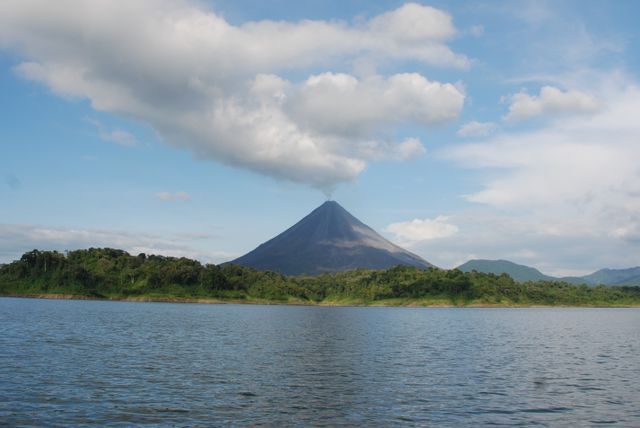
[446,80,640,251]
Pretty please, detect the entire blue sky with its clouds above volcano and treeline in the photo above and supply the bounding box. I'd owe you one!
[0,0,640,274]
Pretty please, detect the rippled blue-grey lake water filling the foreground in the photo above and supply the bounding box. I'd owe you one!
[0,298,640,427]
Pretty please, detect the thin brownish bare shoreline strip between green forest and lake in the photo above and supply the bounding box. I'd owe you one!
[0,293,640,309]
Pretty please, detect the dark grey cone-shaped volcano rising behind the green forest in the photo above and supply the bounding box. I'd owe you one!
[232,201,433,275]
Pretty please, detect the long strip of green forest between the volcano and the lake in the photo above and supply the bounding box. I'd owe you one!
[0,248,640,306]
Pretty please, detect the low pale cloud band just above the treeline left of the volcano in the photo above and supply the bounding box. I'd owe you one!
[0,224,238,263]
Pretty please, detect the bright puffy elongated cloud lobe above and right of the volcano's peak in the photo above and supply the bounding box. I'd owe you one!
[285,73,464,136]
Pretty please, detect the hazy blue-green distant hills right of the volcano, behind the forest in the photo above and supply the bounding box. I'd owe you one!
[457,259,640,285]
